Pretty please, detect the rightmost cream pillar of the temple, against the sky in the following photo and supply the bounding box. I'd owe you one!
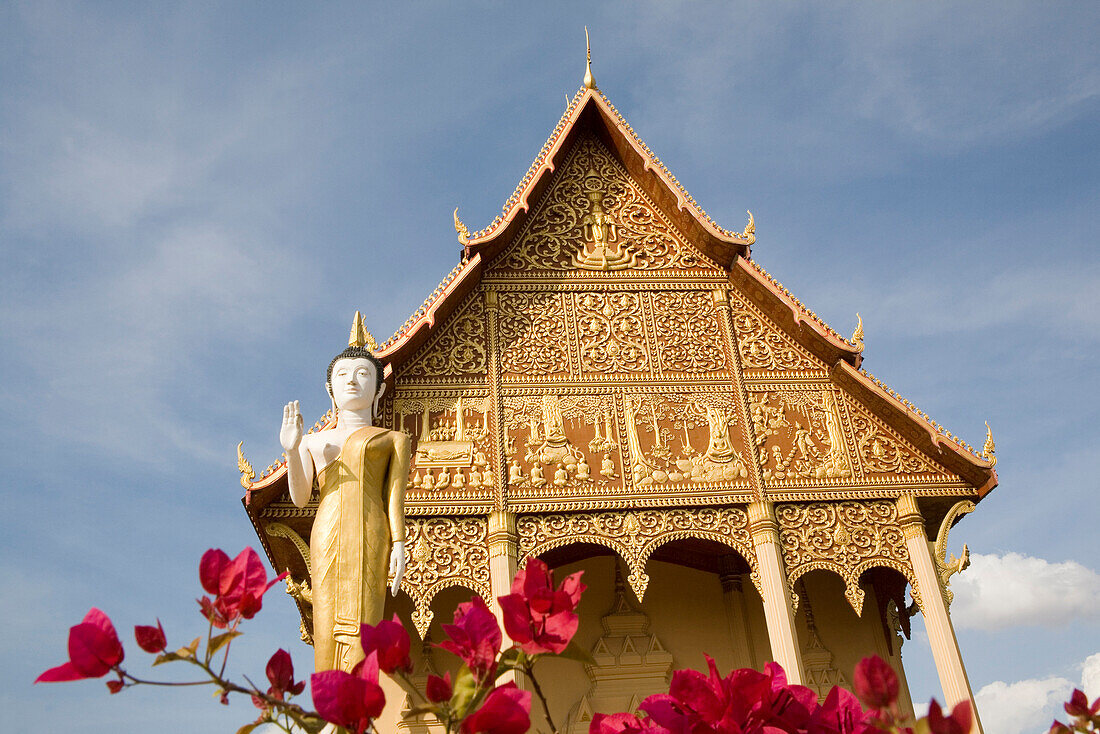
[898,494,982,734]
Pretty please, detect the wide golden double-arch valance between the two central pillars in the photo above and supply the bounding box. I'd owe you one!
[516,507,760,601]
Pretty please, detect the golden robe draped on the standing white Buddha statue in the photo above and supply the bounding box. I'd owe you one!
[309,426,410,671]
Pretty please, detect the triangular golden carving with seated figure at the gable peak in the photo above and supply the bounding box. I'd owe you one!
[491,135,721,275]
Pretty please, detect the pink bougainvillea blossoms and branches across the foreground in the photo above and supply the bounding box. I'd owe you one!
[35,548,1100,734]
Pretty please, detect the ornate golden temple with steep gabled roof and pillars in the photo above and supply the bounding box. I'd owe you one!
[241,64,997,732]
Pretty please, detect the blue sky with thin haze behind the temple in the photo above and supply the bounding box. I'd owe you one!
[0,1,1100,734]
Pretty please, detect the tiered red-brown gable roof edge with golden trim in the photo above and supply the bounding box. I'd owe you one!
[243,87,997,496]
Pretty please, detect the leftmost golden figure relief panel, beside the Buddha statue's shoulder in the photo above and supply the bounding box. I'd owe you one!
[385,387,499,513]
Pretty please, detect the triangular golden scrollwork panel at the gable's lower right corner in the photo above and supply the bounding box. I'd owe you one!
[843,395,960,483]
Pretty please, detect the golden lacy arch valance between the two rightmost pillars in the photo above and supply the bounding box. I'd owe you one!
[776,500,921,614]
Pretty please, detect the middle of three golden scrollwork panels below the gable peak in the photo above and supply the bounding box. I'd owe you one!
[575,293,650,372]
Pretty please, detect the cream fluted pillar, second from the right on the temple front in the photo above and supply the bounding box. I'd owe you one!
[748,502,805,684]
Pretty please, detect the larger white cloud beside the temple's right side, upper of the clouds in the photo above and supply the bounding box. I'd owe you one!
[952,552,1100,633]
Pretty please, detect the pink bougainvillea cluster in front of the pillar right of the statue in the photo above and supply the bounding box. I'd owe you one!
[498,558,585,655]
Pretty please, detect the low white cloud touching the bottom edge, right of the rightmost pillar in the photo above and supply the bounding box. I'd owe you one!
[975,676,1074,734]
